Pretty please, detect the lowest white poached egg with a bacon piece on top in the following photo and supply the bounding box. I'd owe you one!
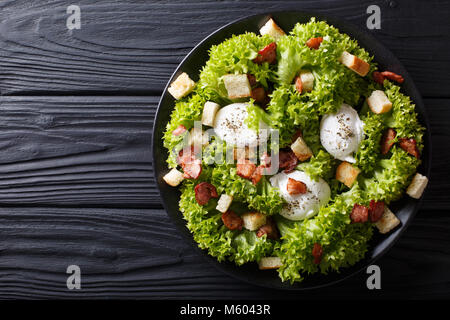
[270,170,331,221]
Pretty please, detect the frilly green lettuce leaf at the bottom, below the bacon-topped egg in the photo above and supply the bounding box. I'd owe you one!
[276,185,372,283]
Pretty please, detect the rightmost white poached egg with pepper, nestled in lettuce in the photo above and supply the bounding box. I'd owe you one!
[320,103,364,163]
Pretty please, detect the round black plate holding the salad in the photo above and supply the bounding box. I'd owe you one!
[152,11,431,290]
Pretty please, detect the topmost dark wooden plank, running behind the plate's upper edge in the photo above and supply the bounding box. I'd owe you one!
[0,0,450,97]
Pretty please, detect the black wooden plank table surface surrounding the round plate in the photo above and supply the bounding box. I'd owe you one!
[0,0,450,299]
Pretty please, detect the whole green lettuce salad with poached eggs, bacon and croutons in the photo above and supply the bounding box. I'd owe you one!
[163,18,428,283]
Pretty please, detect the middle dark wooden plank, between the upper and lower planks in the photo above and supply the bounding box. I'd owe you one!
[0,96,450,210]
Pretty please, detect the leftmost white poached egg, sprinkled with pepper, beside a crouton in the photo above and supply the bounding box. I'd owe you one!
[214,103,269,147]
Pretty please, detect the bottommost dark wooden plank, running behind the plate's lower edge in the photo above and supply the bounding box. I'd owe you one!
[0,207,450,299]
